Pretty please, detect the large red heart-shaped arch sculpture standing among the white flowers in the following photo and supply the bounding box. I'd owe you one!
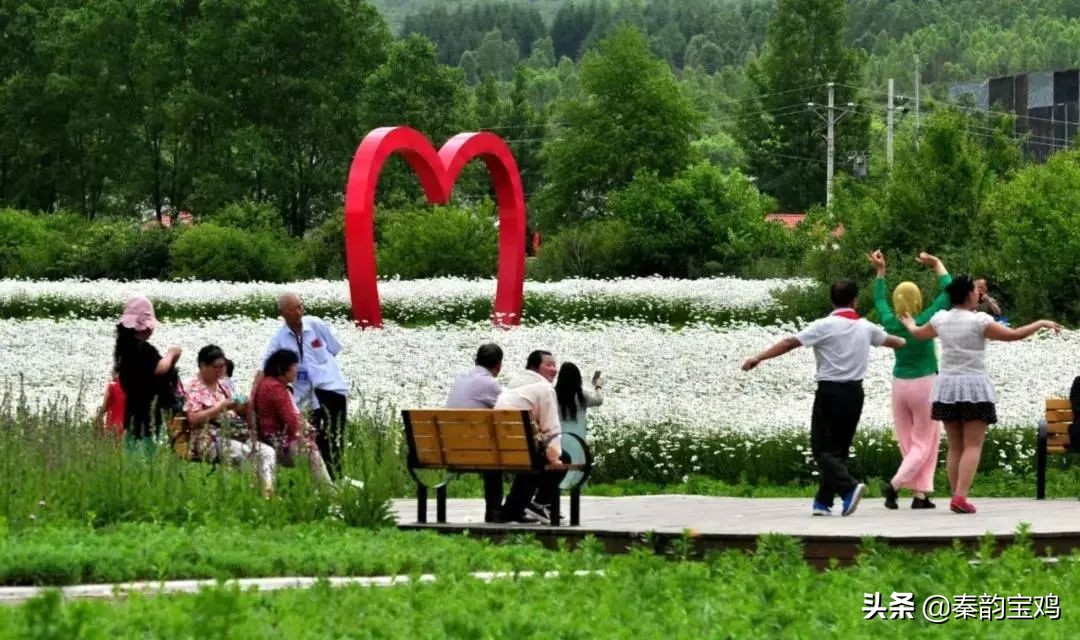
[345,126,525,327]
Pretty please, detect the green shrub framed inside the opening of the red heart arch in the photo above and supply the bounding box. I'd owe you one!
[377,203,498,278]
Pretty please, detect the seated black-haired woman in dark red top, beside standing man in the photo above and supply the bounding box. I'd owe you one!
[251,349,333,486]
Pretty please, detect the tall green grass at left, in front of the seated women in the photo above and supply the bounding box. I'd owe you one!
[0,393,406,530]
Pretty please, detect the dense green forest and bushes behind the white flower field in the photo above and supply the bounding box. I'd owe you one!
[6,0,1080,314]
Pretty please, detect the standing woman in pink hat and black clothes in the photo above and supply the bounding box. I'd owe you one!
[113,296,180,442]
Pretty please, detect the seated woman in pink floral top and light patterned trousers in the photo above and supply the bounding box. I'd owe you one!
[184,344,274,498]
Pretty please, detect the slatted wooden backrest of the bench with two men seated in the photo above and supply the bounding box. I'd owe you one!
[402,409,544,472]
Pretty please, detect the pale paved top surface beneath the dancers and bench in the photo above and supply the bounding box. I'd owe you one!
[394,495,1080,540]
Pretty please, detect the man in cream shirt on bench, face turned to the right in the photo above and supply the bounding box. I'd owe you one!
[495,351,570,525]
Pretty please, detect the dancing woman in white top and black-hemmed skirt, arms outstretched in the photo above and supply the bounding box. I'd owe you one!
[901,275,1062,514]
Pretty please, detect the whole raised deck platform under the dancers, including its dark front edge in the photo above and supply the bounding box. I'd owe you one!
[394,495,1080,566]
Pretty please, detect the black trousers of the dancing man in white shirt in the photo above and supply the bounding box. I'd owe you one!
[810,381,863,506]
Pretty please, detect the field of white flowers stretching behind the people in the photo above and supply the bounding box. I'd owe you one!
[0,271,1067,432]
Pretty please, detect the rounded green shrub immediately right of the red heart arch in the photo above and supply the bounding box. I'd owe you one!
[530,219,633,280]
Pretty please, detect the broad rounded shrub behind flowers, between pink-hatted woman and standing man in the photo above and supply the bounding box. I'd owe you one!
[171,223,298,282]
